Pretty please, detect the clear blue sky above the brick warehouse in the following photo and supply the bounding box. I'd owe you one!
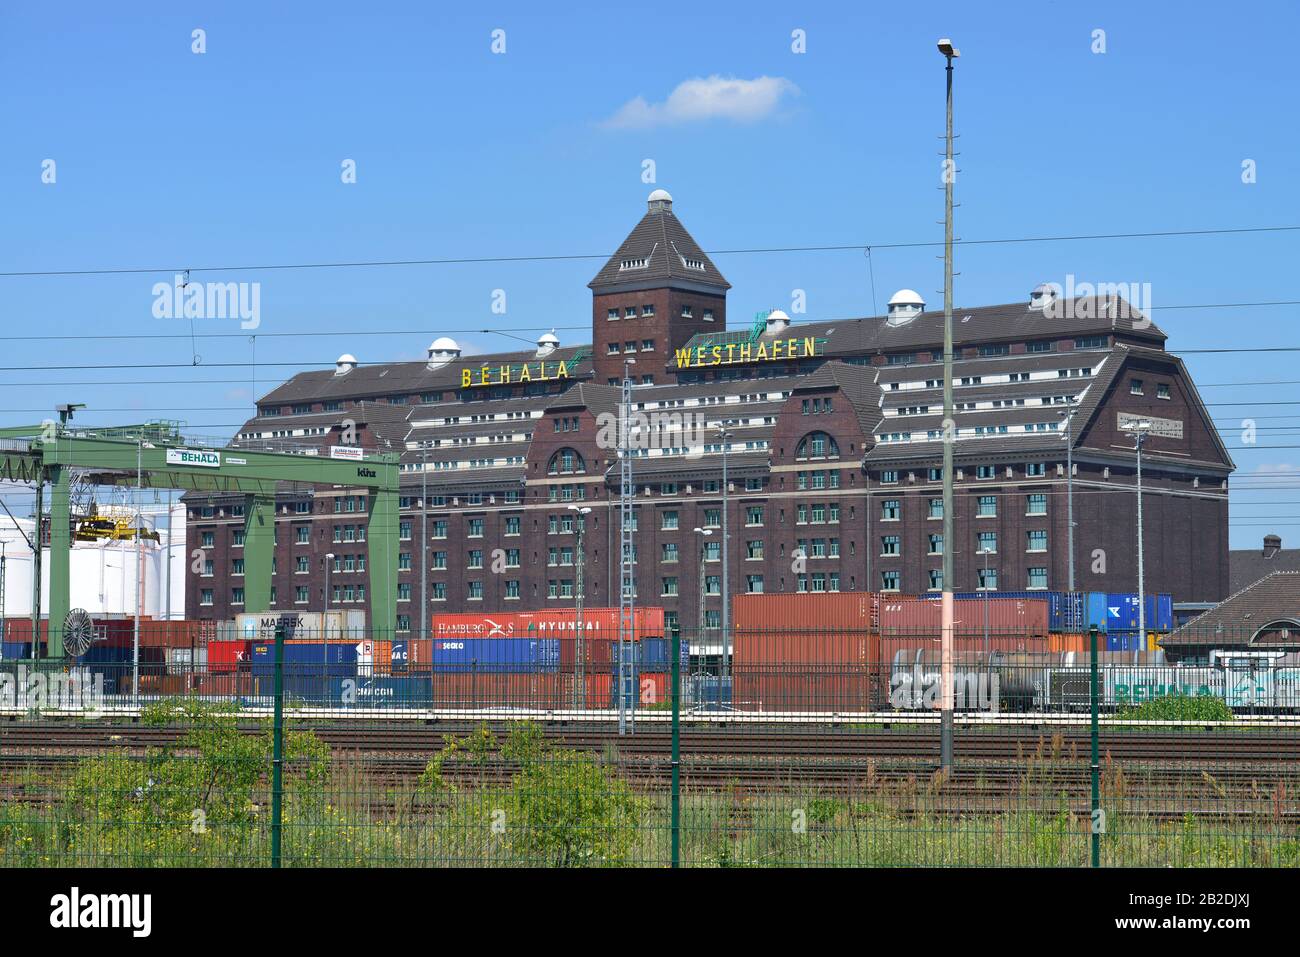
[0,3,1300,547]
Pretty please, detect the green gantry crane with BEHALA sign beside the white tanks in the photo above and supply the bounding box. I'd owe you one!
[0,418,399,658]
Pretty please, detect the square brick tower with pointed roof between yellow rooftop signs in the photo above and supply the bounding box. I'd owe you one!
[588,190,731,385]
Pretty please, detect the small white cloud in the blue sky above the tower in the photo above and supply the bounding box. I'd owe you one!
[603,74,800,130]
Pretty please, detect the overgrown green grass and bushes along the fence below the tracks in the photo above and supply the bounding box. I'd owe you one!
[0,714,1300,867]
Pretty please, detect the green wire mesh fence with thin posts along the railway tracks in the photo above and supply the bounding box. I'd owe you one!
[0,629,1300,867]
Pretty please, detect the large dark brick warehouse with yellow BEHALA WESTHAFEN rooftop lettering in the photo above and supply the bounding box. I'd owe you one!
[186,190,1232,633]
